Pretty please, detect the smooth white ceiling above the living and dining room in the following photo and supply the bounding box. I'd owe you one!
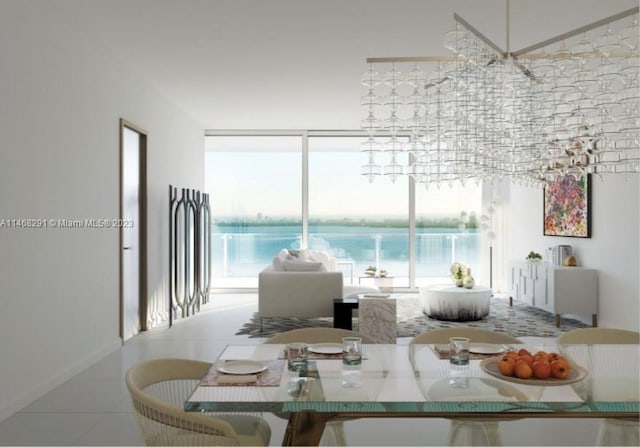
[56,0,638,129]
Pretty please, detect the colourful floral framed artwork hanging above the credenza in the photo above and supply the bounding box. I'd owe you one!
[544,175,591,237]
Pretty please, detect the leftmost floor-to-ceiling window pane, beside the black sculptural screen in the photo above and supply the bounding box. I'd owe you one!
[205,135,302,288]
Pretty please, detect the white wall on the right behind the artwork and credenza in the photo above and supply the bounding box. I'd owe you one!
[505,175,640,331]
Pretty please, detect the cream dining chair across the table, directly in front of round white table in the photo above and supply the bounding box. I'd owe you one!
[409,327,522,446]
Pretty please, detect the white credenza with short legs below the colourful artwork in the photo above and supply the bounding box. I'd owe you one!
[509,261,598,327]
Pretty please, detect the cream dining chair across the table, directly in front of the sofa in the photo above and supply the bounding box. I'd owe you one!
[265,327,374,446]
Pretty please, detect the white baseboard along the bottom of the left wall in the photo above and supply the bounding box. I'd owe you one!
[0,338,122,422]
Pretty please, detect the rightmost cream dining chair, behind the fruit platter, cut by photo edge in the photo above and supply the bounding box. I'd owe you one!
[558,327,640,446]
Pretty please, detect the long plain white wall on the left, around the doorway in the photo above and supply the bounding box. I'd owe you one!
[0,1,204,420]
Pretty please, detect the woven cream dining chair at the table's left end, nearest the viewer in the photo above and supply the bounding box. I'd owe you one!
[125,359,271,446]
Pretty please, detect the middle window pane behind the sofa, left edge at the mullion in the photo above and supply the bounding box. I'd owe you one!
[309,136,409,287]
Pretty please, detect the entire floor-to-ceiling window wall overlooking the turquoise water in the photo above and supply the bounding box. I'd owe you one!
[205,131,481,289]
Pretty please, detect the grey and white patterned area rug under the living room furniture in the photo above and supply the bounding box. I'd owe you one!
[236,294,588,338]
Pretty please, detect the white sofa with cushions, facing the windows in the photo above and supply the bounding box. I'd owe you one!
[258,250,379,329]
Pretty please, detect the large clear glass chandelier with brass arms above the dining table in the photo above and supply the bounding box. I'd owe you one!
[361,3,640,186]
